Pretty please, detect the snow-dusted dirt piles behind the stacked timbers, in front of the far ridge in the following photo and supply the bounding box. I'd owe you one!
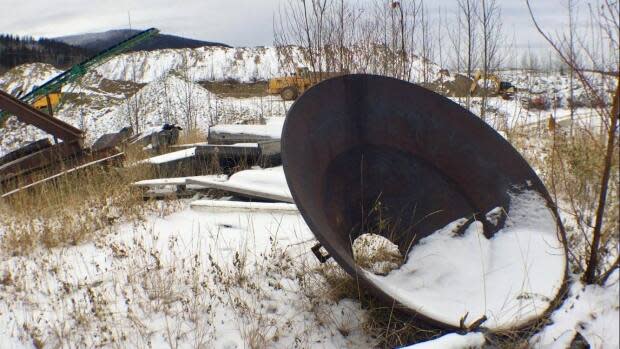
[0,59,291,156]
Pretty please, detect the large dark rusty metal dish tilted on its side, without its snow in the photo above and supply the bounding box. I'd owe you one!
[282,75,565,328]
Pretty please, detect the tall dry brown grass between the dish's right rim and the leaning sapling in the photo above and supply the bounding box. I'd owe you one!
[509,123,620,273]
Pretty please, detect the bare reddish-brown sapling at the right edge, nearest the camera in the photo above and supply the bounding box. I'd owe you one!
[526,0,620,283]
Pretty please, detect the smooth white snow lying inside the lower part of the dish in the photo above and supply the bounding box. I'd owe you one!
[364,191,567,330]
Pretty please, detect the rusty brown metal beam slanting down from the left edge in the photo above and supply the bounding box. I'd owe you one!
[0,90,84,146]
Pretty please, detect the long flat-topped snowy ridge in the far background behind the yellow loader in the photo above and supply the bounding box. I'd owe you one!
[96,46,451,83]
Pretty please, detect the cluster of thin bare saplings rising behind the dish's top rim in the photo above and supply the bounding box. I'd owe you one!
[274,0,432,80]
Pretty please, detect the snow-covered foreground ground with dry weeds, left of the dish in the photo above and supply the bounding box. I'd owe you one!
[0,202,373,348]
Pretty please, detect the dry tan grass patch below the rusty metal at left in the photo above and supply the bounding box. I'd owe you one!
[0,145,157,255]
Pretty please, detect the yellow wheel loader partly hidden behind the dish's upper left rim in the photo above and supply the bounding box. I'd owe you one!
[267,67,343,101]
